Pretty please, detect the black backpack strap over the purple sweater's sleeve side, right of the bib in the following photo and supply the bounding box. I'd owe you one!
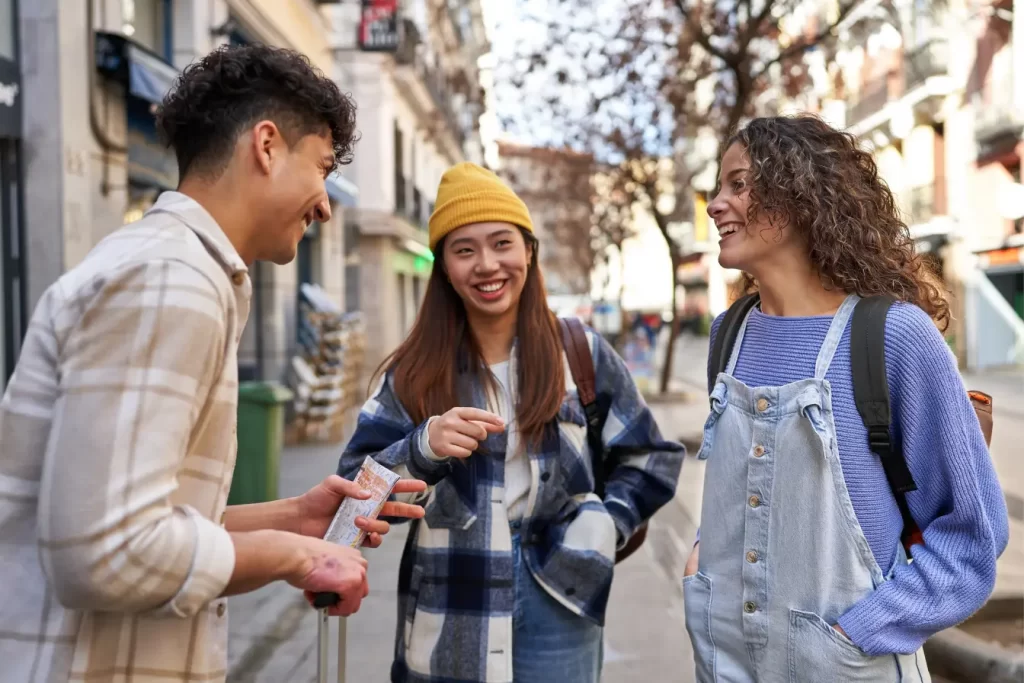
[850,296,920,541]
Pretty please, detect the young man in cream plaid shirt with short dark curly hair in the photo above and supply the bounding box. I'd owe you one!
[0,46,423,683]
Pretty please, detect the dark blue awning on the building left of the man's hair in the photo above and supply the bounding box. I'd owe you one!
[96,32,178,104]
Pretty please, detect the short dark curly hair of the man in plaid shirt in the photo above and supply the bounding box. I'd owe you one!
[157,45,356,177]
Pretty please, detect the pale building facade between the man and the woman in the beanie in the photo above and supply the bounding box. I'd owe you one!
[323,0,489,369]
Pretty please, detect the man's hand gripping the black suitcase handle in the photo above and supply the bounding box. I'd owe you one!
[287,539,370,616]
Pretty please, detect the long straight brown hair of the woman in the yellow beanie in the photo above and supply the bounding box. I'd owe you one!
[374,229,565,444]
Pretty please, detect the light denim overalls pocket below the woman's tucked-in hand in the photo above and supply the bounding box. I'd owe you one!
[788,609,900,683]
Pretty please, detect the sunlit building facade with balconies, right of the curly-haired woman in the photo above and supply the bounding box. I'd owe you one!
[830,0,1024,370]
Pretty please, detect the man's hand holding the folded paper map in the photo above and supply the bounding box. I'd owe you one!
[295,474,427,548]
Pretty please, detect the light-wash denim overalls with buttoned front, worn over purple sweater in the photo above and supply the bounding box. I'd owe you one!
[683,296,931,683]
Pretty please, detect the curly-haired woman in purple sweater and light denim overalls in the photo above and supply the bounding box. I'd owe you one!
[683,117,1008,682]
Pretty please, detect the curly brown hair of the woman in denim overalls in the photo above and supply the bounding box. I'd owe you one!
[724,115,949,331]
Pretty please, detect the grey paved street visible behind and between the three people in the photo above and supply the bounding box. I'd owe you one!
[228,337,1024,683]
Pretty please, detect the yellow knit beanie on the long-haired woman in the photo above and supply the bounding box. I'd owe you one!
[430,162,534,251]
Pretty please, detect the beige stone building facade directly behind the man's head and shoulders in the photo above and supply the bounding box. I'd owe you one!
[18,0,355,380]
